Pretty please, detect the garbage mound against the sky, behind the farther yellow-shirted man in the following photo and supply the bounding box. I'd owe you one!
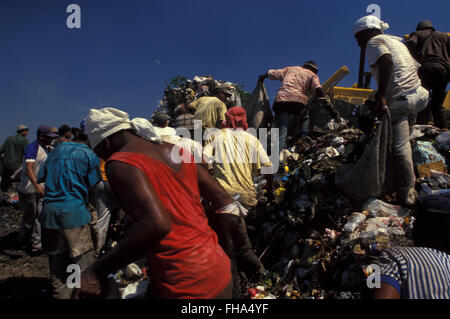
[157,75,242,118]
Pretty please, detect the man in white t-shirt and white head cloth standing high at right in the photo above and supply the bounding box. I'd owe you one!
[353,15,428,206]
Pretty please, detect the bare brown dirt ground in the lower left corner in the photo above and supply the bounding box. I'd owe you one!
[0,203,51,299]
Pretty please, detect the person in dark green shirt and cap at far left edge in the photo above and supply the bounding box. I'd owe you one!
[0,125,30,192]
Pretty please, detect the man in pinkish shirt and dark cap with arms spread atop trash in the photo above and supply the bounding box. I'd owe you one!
[259,61,340,153]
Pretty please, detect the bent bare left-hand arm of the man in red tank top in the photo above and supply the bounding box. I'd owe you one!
[74,162,171,298]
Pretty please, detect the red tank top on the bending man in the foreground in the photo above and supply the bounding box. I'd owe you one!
[108,150,231,299]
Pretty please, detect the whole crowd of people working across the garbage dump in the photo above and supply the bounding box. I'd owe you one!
[1,16,450,298]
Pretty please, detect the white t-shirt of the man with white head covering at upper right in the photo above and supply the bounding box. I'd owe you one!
[367,34,421,104]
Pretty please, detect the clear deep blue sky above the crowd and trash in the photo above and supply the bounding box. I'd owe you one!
[0,0,450,142]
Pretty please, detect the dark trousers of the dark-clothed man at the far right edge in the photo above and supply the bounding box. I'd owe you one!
[417,67,448,128]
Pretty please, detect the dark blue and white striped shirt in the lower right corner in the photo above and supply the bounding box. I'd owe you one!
[380,247,450,299]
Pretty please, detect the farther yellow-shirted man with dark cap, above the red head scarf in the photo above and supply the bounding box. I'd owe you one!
[188,86,231,129]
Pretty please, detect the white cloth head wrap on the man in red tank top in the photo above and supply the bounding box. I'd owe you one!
[84,107,161,148]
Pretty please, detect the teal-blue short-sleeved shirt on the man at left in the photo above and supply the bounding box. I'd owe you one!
[38,142,101,229]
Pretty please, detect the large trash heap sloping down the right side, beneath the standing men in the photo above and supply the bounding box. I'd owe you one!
[246,126,450,299]
